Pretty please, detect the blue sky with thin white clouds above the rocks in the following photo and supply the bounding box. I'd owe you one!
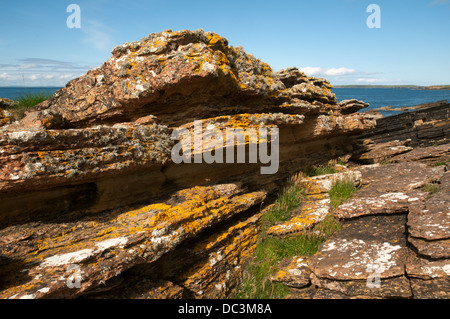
[0,0,450,86]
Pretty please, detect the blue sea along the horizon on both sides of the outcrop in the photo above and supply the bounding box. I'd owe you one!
[0,87,450,116]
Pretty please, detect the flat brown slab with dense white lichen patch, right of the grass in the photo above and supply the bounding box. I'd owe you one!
[309,215,407,280]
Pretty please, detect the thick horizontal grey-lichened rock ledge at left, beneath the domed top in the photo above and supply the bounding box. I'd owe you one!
[0,124,174,192]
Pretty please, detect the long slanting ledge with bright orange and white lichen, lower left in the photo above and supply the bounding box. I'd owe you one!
[0,185,265,298]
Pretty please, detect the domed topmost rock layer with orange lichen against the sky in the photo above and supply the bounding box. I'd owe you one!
[13,30,342,128]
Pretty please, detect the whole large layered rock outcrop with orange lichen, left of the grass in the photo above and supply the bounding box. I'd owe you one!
[0,30,375,298]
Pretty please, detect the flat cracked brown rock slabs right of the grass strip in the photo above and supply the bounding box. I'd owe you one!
[272,162,450,299]
